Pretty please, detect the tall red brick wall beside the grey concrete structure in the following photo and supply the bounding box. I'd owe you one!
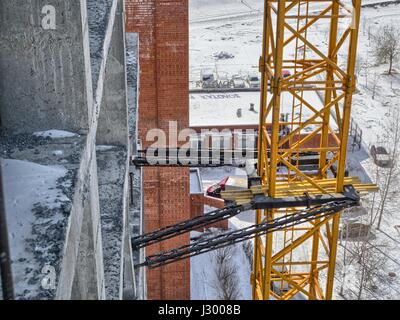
[125,0,190,300]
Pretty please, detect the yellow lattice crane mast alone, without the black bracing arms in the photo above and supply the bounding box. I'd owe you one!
[252,0,361,300]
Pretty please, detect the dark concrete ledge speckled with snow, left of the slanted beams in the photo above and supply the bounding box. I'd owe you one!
[0,134,85,299]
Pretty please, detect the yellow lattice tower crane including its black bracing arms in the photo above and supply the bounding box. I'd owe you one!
[132,0,377,300]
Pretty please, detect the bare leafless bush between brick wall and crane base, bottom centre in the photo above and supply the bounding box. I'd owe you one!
[213,246,240,300]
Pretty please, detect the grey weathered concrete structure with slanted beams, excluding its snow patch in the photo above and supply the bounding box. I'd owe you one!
[0,0,142,299]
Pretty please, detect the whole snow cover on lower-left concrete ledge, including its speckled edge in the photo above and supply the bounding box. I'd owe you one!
[1,159,70,299]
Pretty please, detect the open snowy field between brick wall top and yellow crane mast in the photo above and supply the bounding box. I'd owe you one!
[189,0,262,81]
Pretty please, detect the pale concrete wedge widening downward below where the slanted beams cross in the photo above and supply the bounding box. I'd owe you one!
[69,144,105,300]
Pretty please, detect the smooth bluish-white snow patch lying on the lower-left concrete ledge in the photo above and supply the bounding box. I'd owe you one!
[1,159,68,294]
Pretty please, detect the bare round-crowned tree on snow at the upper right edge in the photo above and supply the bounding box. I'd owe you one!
[373,25,400,75]
